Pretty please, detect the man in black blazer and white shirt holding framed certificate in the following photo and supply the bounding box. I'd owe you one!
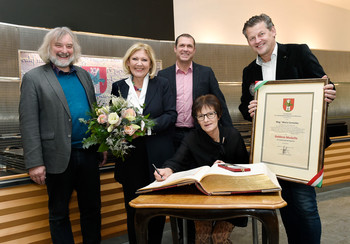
[239,14,336,244]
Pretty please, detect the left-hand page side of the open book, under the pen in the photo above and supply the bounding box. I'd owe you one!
[138,166,210,191]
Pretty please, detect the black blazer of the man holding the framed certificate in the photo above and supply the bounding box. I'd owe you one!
[239,43,331,146]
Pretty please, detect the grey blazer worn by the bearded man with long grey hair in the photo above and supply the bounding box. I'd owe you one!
[19,64,96,174]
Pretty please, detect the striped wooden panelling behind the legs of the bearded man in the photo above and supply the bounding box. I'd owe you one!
[0,172,127,244]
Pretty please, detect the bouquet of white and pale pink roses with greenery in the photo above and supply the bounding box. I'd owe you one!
[80,95,155,160]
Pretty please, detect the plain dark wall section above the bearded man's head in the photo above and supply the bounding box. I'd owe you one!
[0,0,174,40]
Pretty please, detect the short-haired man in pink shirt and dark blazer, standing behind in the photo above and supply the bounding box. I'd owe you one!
[158,34,232,148]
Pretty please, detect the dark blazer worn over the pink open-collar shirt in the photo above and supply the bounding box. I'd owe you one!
[158,62,232,126]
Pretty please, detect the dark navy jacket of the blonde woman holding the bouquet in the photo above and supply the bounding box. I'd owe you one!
[112,77,177,183]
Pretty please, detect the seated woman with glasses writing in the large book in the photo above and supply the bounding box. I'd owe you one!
[154,94,249,244]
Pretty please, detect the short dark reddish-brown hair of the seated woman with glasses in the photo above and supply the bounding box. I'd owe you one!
[192,94,222,119]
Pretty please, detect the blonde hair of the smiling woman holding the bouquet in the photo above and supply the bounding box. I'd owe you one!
[123,43,157,78]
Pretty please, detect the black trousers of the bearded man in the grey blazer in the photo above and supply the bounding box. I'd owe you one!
[46,149,101,244]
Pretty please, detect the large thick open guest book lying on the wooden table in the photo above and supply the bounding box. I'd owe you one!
[136,163,281,195]
